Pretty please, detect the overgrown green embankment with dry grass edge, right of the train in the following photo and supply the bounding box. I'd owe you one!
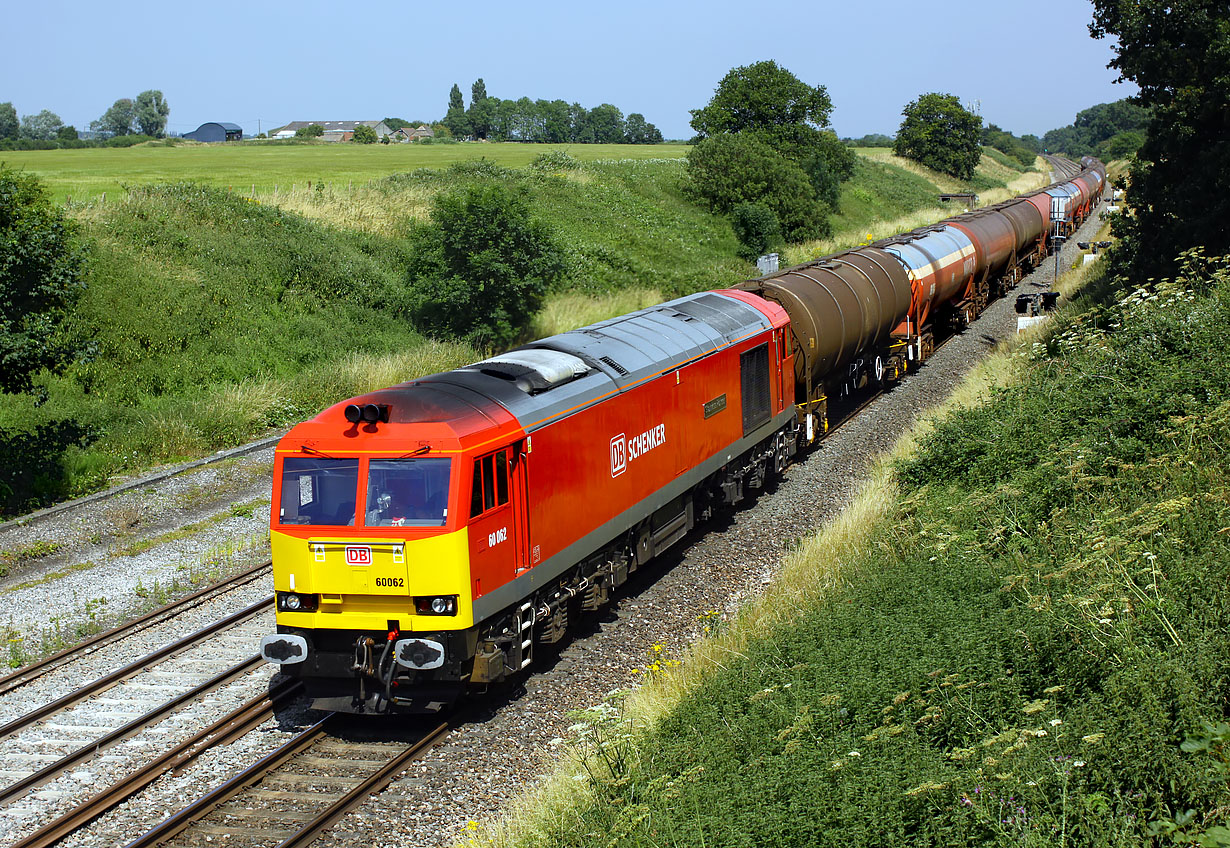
[484,251,1230,846]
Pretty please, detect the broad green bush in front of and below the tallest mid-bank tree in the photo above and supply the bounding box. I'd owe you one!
[688,133,828,241]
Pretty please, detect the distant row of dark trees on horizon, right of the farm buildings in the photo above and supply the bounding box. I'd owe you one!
[440,78,663,144]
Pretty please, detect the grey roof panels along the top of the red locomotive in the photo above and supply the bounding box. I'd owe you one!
[418,292,771,432]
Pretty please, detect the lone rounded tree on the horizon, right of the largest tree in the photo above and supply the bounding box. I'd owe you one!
[893,92,983,180]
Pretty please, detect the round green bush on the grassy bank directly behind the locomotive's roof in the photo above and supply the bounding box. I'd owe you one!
[411,185,565,347]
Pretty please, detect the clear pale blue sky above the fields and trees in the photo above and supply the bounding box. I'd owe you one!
[0,0,1135,138]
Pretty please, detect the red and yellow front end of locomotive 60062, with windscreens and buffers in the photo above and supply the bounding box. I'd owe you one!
[261,389,523,713]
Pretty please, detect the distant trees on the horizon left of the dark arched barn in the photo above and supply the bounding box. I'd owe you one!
[0,89,171,150]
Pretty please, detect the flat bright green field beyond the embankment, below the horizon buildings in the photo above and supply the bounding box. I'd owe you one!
[0,142,688,203]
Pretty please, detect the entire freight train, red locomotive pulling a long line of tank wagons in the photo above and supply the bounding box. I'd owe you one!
[261,160,1105,713]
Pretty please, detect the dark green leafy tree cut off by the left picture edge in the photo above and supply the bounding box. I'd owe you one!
[0,167,85,393]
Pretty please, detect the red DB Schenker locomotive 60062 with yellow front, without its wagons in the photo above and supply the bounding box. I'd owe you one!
[261,292,796,713]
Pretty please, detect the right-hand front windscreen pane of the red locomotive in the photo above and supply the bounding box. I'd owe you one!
[363,459,453,527]
